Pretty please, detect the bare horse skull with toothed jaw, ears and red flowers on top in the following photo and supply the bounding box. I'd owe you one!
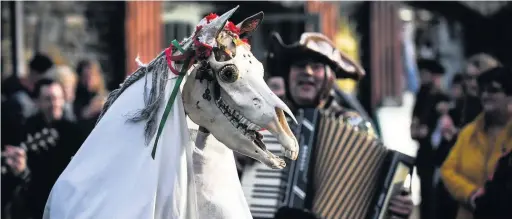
[183,8,299,168]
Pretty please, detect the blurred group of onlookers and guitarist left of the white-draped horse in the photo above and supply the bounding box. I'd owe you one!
[1,53,108,219]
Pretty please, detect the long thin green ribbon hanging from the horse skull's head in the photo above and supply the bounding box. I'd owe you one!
[151,40,192,160]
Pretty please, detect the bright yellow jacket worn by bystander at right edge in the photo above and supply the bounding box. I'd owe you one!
[441,114,512,219]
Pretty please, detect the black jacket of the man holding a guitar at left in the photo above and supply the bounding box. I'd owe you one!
[20,114,85,218]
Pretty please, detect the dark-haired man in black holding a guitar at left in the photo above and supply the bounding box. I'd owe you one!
[8,79,84,218]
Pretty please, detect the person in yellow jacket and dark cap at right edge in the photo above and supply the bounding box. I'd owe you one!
[441,67,512,219]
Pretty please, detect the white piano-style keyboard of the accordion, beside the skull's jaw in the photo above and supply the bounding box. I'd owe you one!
[241,131,284,219]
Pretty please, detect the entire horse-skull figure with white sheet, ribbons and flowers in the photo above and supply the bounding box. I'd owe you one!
[43,8,298,219]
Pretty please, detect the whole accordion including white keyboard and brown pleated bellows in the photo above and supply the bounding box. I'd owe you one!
[242,109,414,219]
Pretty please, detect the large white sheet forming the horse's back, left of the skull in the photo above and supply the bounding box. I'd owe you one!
[44,71,198,219]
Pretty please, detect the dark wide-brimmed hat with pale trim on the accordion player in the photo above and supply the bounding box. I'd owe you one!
[272,32,365,80]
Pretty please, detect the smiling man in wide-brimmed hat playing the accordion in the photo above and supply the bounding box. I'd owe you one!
[243,33,413,219]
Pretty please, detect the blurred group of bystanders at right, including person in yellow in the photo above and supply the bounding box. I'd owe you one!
[411,54,512,219]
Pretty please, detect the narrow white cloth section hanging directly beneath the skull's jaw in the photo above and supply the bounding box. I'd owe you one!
[191,130,252,219]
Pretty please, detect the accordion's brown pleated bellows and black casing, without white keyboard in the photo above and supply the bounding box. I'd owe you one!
[283,110,414,219]
